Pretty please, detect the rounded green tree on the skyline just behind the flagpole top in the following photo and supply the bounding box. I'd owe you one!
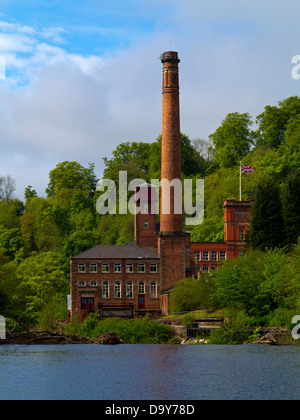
[209,112,254,168]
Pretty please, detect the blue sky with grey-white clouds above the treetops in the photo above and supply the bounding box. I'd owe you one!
[0,0,300,200]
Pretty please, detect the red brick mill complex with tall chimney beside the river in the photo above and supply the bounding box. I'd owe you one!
[70,51,251,317]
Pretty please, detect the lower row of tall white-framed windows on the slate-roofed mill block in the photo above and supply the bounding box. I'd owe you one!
[78,280,157,299]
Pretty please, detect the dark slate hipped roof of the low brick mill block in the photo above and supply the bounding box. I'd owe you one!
[73,244,159,259]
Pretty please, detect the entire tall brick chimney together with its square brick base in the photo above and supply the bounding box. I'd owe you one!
[158,51,186,313]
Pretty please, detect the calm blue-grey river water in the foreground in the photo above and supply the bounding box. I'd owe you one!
[0,344,300,401]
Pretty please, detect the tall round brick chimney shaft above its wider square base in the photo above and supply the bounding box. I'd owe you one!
[160,51,182,233]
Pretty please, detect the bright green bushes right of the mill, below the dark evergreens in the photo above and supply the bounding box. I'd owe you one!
[213,245,300,319]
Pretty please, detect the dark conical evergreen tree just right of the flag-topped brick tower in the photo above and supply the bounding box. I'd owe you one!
[250,178,284,250]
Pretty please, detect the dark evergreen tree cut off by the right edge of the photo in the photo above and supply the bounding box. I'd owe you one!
[282,172,300,245]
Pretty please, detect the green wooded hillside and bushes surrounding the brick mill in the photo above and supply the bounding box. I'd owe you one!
[0,96,300,342]
